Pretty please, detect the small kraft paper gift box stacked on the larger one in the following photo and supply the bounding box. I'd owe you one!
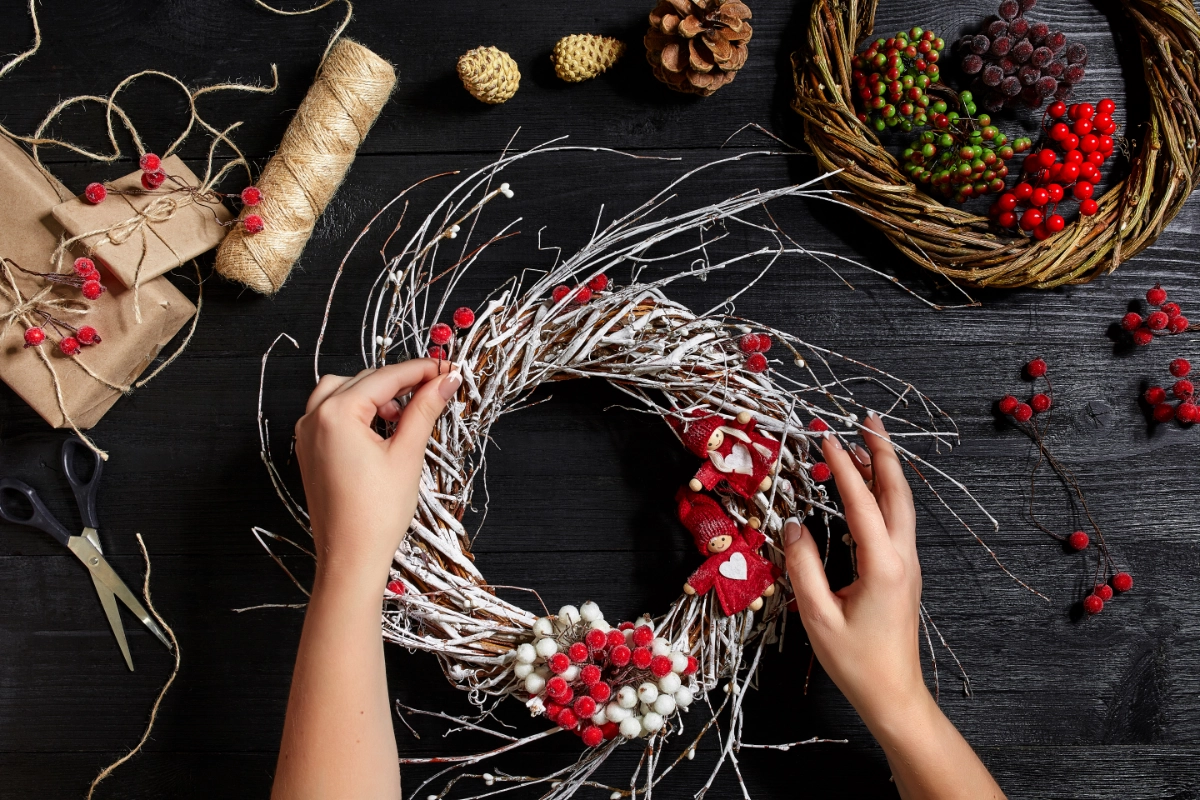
[54,156,233,287]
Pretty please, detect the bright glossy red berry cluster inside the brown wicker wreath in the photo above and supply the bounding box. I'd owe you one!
[991,98,1116,235]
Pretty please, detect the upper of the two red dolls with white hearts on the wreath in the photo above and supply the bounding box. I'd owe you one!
[668,410,779,498]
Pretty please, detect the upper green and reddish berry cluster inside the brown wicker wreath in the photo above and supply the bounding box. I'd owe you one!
[851,28,946,132]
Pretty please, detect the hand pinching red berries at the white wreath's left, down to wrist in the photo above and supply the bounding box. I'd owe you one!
[296,359,462,588]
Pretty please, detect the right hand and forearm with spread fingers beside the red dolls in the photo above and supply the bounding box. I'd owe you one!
[785,414,1004,800]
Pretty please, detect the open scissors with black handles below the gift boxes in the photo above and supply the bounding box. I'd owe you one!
[0,437,172,670]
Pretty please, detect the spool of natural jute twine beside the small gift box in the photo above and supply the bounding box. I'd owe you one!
[216,38,396,295]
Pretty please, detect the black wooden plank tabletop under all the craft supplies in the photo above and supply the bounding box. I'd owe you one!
[0,0,1200,800]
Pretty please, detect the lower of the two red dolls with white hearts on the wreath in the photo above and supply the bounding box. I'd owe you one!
[676,488,782,616]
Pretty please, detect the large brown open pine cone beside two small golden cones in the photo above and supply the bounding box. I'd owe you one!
[646,0,754,96]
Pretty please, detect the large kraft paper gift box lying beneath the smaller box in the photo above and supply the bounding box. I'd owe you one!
[0,136,196,428]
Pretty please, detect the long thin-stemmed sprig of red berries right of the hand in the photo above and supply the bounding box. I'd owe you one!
[997,357,1128,614]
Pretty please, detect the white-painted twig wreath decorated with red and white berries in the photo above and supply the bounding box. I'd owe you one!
[256,143,1007,799]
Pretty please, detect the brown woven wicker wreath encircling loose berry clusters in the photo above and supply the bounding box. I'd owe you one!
[792,0,1200,289]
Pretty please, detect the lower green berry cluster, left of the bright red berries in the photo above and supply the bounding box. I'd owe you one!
[901,101,1033,203]
